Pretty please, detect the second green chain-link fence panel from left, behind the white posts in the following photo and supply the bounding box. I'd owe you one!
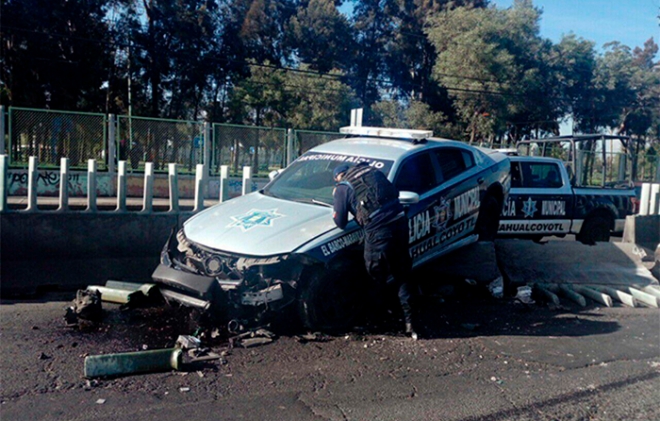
[116,116,204,172]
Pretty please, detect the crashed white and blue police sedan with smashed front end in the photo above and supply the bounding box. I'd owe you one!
[153,127,510,330]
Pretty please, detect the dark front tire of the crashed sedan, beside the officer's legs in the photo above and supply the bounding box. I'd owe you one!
[298,268,364,333]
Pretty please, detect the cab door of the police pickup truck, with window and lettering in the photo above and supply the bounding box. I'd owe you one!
[498,160,573,236]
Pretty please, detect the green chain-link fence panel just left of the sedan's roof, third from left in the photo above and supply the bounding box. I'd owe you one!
[210,123,286,176]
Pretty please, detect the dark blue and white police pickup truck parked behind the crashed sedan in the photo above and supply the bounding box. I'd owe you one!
[498,155,636,245]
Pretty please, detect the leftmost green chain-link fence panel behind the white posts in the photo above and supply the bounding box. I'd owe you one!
[7,107,107,169]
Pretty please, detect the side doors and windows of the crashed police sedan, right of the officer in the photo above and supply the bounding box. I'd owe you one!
[394,144,479,265]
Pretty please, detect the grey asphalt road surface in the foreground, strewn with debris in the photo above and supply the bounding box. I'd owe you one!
[0,283,660,421]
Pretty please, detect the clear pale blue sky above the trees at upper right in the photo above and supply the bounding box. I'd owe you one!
[491,0,660,54]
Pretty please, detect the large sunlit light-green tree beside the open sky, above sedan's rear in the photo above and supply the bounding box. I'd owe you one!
[427,0,561,142]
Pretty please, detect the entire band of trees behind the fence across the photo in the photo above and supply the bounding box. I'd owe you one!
[0,0,660,146]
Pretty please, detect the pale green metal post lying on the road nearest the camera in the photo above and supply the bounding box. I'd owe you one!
[85,348,182,378]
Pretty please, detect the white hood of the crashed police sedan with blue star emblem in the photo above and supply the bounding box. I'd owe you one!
[184,192,335,256]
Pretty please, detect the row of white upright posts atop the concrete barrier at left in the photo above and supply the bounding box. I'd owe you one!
[0,155,255,213]
